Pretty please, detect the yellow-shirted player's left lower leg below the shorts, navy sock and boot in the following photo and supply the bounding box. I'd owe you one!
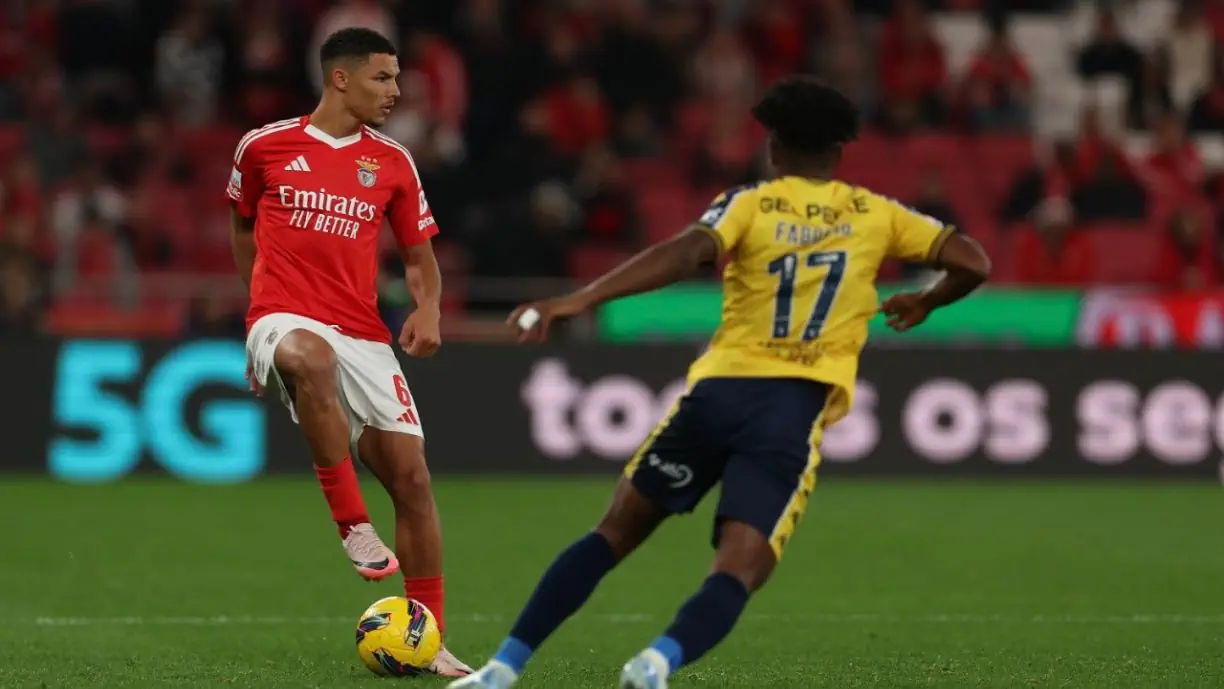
[448,479,667,689]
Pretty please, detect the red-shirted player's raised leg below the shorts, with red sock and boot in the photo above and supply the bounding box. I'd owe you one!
[273,329,399,580]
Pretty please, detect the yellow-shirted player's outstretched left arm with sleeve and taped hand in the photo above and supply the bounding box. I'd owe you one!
[507,190,755,341]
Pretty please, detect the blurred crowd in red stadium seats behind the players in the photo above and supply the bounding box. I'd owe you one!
[0,0,1224,334]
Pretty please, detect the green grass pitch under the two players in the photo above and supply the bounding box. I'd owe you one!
[0,480,1224,689]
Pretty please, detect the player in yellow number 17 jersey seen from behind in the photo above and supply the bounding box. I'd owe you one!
[450,77,990,689]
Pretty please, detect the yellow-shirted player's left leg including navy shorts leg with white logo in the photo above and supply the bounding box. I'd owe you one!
[450,386,722,689]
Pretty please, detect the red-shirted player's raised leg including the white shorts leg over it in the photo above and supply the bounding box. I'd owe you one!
[247,315,399,580]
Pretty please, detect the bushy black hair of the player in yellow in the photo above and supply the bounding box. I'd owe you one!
[753,75,859,155]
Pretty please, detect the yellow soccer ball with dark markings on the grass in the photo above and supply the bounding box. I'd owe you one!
[357,596,442,677]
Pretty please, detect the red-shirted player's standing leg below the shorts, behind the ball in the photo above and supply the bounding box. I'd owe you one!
[357,427,472,677]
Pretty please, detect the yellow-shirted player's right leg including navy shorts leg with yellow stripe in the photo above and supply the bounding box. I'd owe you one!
[621,381,829,689]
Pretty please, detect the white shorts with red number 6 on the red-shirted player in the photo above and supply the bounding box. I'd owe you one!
[246,313,425,453]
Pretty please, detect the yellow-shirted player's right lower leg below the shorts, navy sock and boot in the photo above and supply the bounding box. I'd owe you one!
[621,520,777,689]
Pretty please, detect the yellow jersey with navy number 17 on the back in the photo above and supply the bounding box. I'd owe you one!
[689,177,953,425]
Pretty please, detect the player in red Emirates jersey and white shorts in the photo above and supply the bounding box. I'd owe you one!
[226,28,471,677]
